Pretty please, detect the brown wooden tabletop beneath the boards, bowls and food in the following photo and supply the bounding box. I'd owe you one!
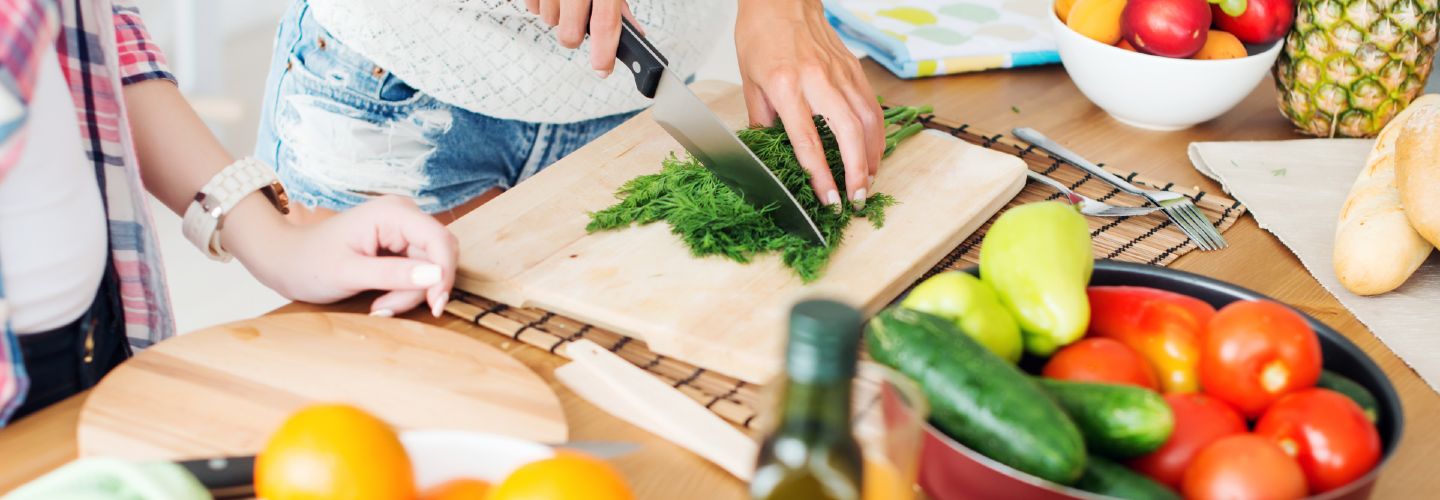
[0,62,1440,499]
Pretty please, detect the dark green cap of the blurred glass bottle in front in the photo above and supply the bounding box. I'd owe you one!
[785,300,863,382]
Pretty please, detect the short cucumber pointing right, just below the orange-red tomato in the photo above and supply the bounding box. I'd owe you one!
[1035,378,1175,458]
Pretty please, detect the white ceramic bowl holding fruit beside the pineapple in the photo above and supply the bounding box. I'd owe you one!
[1050,7,1282,130]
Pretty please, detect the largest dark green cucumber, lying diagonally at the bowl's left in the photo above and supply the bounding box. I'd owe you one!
[865,308,1086,484]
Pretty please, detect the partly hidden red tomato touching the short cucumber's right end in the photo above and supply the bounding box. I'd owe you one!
[1130,393,1246,488]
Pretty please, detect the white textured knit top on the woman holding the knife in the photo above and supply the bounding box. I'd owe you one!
[310,0,726,122]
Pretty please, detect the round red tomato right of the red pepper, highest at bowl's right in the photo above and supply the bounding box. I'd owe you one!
[1200,300,1320,418]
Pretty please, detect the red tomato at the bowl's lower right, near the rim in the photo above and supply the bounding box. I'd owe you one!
[1256,388,1380,493]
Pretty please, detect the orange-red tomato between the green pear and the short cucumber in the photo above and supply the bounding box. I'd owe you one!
[1041,339,1158,390]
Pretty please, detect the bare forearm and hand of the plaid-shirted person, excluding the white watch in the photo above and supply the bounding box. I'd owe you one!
[124,58,459,316]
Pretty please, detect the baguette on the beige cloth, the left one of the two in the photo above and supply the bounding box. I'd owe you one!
[1335,95,1440,295]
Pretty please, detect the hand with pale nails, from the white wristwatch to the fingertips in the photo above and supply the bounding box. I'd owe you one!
[222,196,459,317]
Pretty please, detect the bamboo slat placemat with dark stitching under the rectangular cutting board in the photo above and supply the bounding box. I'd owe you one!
[445,117,1246,429]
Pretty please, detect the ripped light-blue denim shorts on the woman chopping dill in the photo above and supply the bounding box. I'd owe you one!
[255,0,634,213]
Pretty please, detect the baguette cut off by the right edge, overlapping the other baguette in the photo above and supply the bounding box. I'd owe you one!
[1395,98,1440,248]
